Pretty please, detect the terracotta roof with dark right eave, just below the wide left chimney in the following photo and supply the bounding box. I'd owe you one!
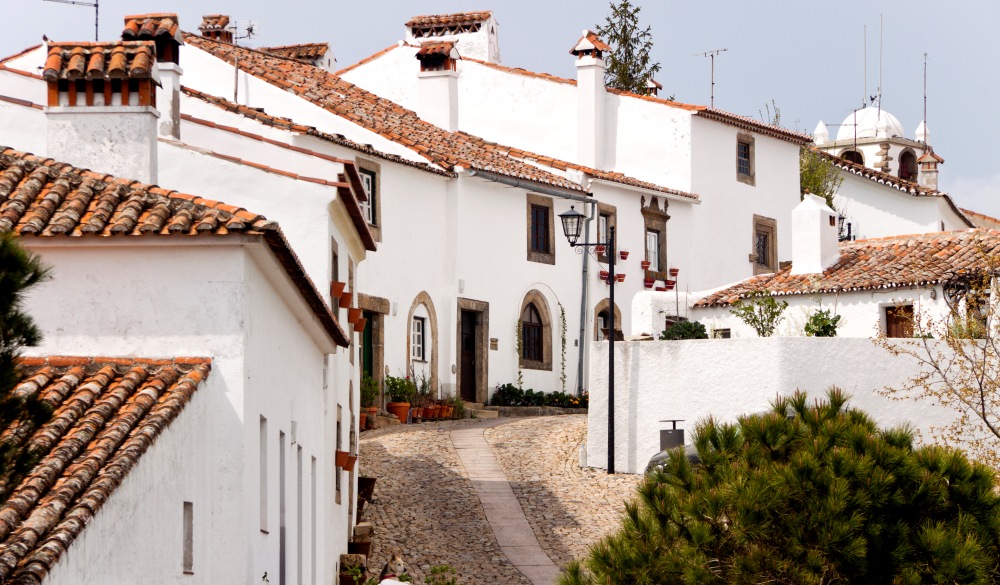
[0,146,350,347]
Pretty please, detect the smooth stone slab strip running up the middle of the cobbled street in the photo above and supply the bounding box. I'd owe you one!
[451,419,559,585]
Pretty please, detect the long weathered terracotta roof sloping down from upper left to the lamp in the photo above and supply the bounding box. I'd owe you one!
[186,34,583,191]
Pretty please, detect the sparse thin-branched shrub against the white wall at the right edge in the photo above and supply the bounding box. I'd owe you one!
[875,253,1000,470]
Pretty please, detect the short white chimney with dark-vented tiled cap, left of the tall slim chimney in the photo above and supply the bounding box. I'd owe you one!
[417,41,460,132]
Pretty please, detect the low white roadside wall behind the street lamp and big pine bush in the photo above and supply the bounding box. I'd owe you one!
[587,337,954,473]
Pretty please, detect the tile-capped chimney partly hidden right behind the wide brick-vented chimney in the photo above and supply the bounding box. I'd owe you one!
[122,14,184,140]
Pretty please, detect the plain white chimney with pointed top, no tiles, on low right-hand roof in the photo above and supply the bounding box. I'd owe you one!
[792,193,840,275]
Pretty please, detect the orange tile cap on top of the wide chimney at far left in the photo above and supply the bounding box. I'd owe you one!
[42,41,156,81]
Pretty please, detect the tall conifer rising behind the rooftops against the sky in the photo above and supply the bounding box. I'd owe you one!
[594,0,673,93]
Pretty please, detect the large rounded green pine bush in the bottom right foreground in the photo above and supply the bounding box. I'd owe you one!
[559,389,1000,585]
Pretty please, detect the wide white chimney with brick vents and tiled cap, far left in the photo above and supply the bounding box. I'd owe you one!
[42,41,160,183]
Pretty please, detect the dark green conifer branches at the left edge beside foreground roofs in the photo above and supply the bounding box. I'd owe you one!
[0,233,51,501]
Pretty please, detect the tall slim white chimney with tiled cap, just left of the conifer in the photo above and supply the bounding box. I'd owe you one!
[570,30,611,169]
